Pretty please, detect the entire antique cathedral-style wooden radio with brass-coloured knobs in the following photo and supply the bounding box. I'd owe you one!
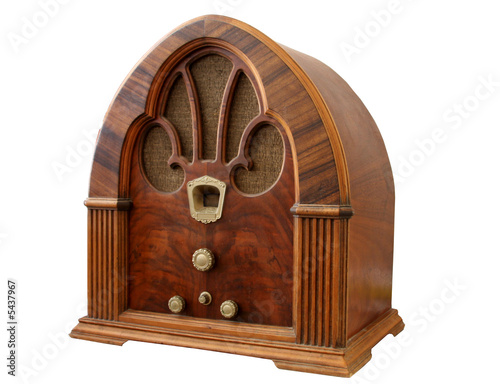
[71,16,404,376]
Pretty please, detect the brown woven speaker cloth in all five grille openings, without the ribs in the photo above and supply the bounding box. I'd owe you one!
[142,54,284,195]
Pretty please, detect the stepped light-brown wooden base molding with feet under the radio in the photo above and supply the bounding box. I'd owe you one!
[70,309,404,377]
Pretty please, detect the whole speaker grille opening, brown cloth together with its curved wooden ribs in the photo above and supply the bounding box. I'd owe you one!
[142,47,285,195]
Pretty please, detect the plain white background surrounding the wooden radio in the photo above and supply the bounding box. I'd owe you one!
[0,0,500,384]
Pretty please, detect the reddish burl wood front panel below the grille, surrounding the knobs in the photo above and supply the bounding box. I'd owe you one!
[128,124,294,326]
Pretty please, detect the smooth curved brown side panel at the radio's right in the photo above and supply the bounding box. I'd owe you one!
[286,48,395,337]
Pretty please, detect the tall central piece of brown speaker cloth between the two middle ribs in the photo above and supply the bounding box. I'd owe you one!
[190,54,233,160]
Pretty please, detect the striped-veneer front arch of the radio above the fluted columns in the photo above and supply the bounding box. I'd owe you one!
[89,16,340,204]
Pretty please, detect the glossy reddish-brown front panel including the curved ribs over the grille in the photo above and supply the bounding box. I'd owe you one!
[127,44,295,327]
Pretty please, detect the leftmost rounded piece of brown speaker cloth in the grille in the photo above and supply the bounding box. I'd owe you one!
[142,127,184,192]
